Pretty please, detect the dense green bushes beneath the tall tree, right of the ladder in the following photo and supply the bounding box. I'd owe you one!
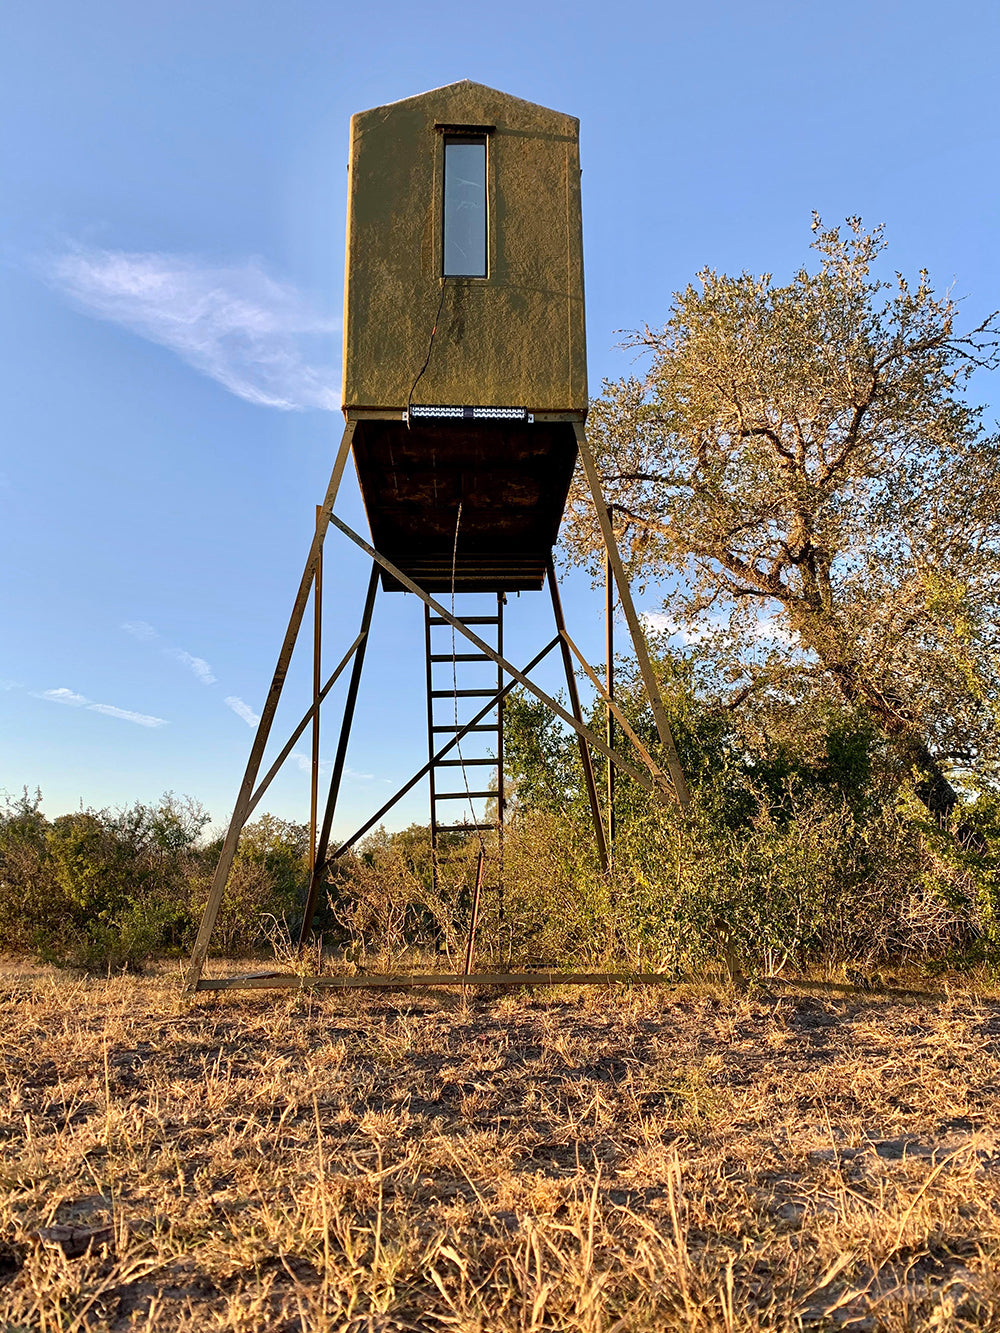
[505,645,1000,972]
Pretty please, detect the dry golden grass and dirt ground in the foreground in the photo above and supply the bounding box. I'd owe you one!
[0,965,1000,1333]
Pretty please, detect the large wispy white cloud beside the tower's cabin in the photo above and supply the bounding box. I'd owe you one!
[43,247,340,412]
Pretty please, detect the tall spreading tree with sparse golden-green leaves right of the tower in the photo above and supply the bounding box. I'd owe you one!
[568,217,1000,818]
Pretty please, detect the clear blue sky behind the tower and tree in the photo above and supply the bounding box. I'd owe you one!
[0,0,1000,832]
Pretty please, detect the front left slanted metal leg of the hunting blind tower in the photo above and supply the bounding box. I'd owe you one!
[184,421,355,993]
